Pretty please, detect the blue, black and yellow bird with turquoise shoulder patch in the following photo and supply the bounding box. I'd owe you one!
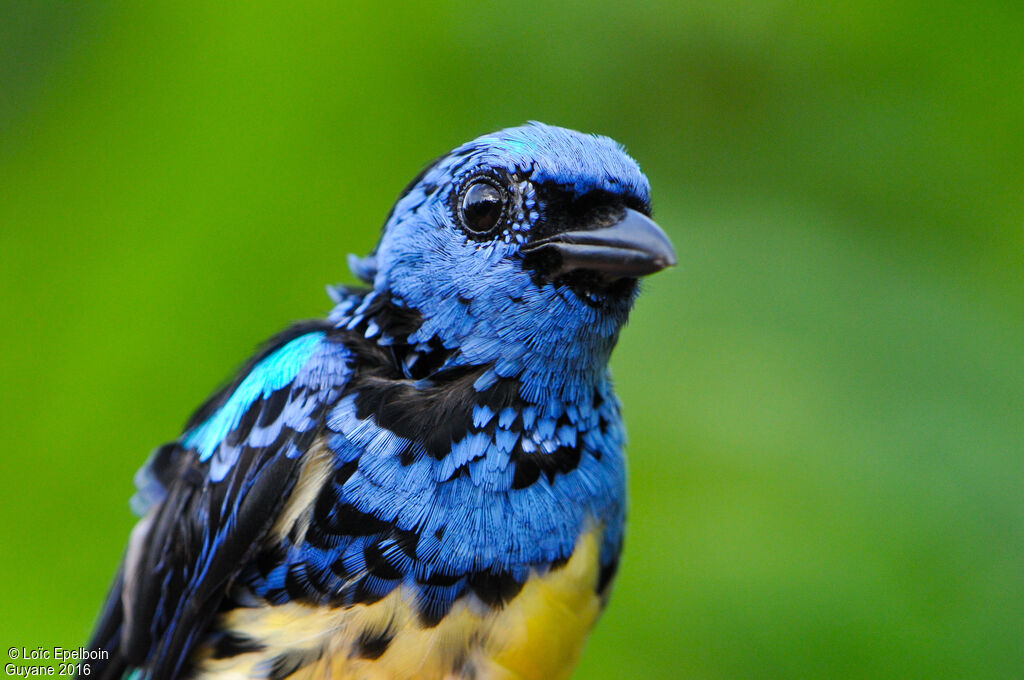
[81,122,677,680]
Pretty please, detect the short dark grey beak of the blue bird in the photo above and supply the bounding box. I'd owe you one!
[522,208,677,280]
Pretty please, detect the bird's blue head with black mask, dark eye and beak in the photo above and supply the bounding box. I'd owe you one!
[351,123,676,378]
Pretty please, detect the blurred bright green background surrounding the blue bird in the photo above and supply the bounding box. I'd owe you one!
[0,0,1024,679]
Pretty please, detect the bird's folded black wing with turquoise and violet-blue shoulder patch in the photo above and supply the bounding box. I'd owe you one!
[91,322,351,680]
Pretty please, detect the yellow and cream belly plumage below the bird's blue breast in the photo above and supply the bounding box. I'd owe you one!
[195,528,601,680]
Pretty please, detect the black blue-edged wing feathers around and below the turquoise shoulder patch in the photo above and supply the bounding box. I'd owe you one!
[83,321,331,680]
